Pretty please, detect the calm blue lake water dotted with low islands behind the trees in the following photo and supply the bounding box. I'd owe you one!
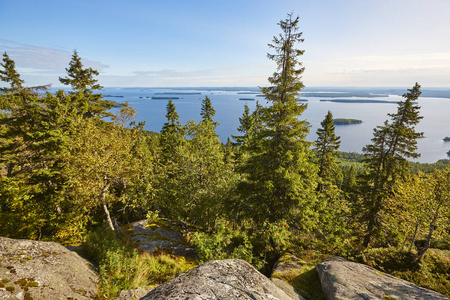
[98,88,450,163]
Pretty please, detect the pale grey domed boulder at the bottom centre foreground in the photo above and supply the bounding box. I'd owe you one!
[141,259,292,300]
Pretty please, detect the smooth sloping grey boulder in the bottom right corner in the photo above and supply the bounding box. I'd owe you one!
[316,257,449,300]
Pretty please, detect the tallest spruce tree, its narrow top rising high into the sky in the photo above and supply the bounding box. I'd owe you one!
[239,14,317,228]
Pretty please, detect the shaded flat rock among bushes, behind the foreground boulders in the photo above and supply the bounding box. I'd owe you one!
[129,220,196,258]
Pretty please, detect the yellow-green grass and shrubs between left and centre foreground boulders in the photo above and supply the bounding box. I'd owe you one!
[83,227,195,299]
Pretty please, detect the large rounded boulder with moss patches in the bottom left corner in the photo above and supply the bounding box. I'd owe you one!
[0,237,98,300]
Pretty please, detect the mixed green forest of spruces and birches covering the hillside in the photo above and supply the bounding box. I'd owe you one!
[0,15,450,299]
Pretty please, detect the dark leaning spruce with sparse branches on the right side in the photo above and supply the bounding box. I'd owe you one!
[359,83,423,247]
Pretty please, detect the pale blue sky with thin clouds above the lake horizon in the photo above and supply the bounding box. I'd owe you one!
[0,0,450,87]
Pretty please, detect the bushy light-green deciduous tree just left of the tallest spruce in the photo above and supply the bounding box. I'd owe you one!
[155,97,235,229]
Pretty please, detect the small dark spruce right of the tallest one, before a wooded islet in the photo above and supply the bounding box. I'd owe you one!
[314,111,341,192]
